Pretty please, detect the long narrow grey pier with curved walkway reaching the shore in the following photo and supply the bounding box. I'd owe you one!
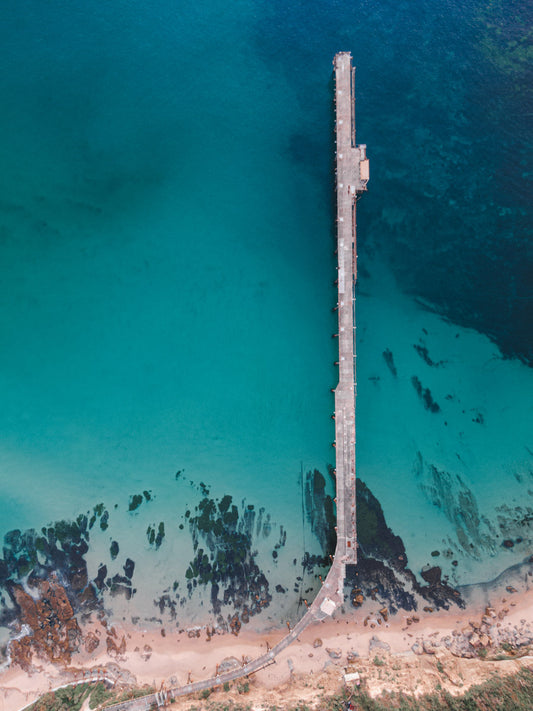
[19,52,369,711]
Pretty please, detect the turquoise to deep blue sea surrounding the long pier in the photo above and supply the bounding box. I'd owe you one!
[0,0,533,636]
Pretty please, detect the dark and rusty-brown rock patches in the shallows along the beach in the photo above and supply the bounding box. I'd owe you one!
[0,470,531,671]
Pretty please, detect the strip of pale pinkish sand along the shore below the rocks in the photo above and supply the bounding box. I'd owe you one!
[0,570,533,711]
